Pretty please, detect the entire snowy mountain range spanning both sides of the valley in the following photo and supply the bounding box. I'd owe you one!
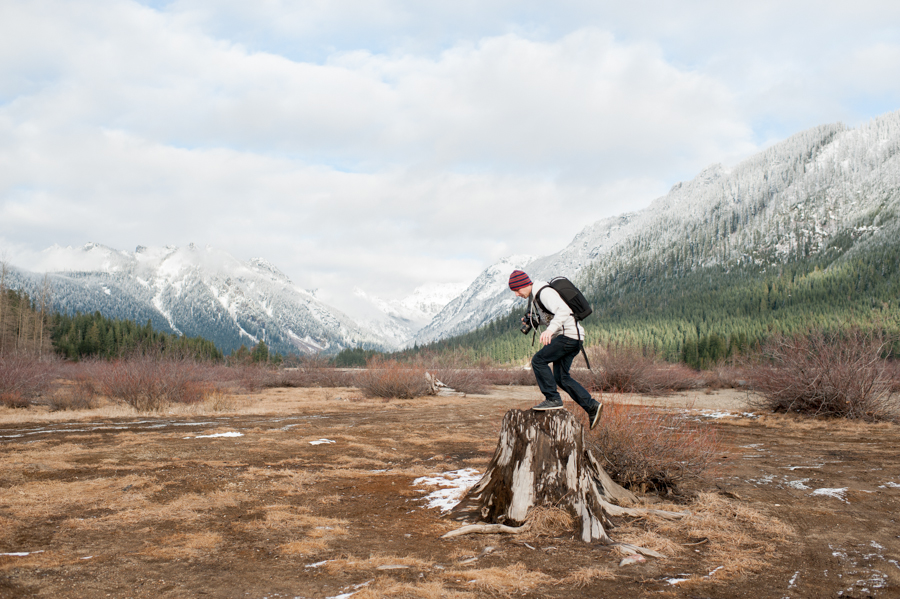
[9,111,900,352]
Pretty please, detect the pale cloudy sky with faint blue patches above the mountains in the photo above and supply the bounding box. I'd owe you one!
[0,0,900,310]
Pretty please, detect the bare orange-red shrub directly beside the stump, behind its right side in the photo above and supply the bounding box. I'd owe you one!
[578,397,718,492]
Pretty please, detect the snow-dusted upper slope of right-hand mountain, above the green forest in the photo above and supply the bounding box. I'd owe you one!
[416,111,900,344]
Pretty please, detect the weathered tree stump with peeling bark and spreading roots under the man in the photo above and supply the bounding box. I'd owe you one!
[450,410,682,544]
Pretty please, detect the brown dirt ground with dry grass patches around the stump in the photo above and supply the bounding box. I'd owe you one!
[0,387,900,599]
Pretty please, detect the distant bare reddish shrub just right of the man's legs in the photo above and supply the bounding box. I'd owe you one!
[573,343,698,395]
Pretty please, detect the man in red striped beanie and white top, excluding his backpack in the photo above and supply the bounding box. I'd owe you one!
[509,270,603,428]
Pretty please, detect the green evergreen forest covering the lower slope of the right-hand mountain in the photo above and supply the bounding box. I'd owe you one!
[399,245,900,367]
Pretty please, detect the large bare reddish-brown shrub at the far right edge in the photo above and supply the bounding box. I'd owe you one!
[750,329,900,421]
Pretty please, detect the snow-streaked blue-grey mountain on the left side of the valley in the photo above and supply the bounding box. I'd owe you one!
[8,243,388,353]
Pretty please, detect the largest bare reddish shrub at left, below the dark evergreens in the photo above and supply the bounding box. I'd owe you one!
[96,356,223,412]
